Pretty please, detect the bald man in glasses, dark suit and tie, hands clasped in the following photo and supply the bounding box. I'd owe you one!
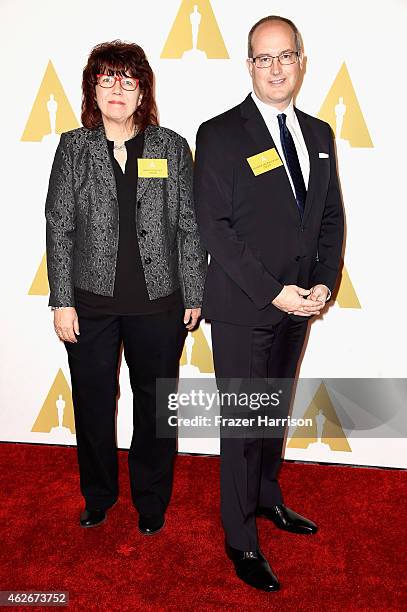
[195,16,343,591]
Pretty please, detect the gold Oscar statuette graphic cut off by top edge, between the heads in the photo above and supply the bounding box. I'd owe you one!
[161,0,229,60]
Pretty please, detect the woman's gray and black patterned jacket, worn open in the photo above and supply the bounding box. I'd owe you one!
[45,126,206,308]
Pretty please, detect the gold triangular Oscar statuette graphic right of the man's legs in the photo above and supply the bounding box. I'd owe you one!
[287,383,352,452]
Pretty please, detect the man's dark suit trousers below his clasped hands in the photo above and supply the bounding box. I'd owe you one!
[212,317,308,551]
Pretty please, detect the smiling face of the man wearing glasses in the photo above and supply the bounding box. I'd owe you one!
[247,21,302,110]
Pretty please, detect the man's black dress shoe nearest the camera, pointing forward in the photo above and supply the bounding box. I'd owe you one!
[226,544,280,591]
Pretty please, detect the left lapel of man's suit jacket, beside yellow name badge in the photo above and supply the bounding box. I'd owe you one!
[241,94,299,222]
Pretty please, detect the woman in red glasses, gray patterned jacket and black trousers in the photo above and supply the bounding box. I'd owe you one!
[46,41,206,534]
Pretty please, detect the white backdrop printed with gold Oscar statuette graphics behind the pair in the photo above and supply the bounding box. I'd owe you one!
[0,0,407,467]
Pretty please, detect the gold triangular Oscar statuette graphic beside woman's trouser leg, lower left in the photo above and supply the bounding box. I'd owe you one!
[31,369,75,437]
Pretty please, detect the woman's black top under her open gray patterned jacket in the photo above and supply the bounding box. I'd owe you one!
[75,134,182,314]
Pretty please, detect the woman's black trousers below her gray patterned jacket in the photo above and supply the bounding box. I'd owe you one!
[65,308,186,514]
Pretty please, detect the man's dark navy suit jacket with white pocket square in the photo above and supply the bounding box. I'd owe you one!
[194,95,344,326]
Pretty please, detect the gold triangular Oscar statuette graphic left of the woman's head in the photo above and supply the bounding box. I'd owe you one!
[21,60,79,142]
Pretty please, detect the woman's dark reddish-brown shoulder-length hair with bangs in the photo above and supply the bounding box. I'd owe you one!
[81,40,158,131]
